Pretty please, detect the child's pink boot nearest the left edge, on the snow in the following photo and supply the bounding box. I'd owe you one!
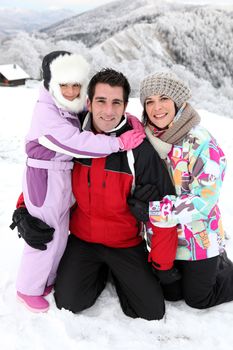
[17,292,49,312]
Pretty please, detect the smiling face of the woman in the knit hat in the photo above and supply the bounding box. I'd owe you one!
[145,95,176,129]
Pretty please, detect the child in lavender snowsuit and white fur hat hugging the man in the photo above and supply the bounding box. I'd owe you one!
[14,51,144,312]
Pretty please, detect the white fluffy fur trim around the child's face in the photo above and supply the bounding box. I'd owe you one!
[49,54,89,113]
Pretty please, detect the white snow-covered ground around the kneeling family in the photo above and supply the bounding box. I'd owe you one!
[0,87,233,350]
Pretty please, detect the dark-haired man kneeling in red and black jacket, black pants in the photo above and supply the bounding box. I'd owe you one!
[11,69,174,320]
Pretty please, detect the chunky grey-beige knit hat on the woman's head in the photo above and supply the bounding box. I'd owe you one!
[140,72,191,108]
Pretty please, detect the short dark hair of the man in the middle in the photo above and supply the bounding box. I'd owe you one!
[87,68,131,103]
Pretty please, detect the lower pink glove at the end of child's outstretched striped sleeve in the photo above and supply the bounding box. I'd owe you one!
[118,130,146,151]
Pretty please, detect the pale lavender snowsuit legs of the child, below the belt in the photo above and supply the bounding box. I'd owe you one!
[16,170,71,296]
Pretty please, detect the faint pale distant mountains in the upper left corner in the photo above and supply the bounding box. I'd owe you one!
[0,7,75,37]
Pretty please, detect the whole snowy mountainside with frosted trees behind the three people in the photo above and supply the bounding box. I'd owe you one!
[0,0,233,118]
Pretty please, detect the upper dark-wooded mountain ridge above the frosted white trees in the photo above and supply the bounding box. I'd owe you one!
[42,0,233,87]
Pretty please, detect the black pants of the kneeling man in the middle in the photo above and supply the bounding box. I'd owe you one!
[54,234,165,320]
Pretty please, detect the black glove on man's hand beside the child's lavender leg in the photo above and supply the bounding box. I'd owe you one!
[10,207,55,250]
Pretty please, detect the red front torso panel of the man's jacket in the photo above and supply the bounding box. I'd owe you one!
[70,157,142,248]
